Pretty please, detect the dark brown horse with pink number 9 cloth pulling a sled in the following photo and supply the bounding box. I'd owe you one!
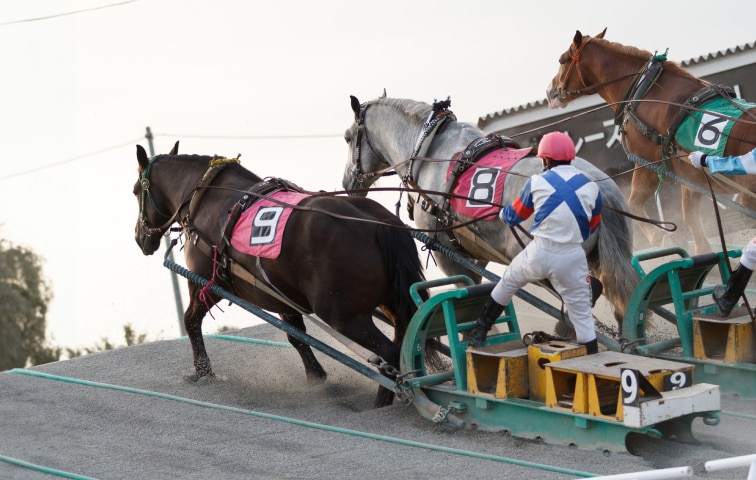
[134,142,424,407]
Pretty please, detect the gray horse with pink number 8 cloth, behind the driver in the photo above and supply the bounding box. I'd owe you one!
[342,94,638,328]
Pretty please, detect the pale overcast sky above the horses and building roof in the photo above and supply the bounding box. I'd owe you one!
[0,0,756,348]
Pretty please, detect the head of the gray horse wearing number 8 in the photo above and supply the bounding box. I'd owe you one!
[341,91,386,197]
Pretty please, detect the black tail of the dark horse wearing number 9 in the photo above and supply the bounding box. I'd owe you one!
[377,225,428,340]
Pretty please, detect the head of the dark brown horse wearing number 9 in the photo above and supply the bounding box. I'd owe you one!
[134,142,178,255]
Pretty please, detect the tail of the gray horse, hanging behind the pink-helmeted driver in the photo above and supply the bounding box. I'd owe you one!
[588,189,640,327]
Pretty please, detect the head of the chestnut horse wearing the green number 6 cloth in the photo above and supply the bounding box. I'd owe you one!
[546,28,606,108]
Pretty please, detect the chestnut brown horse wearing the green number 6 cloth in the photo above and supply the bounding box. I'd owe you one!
[547,29,756,253]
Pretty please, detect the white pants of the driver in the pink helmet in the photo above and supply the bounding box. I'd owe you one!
[491,237,596,343]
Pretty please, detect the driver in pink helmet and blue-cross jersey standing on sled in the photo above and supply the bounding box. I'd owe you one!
[470,132,602,354]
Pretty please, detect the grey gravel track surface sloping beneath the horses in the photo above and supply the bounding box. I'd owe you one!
[0,318,756,480]
